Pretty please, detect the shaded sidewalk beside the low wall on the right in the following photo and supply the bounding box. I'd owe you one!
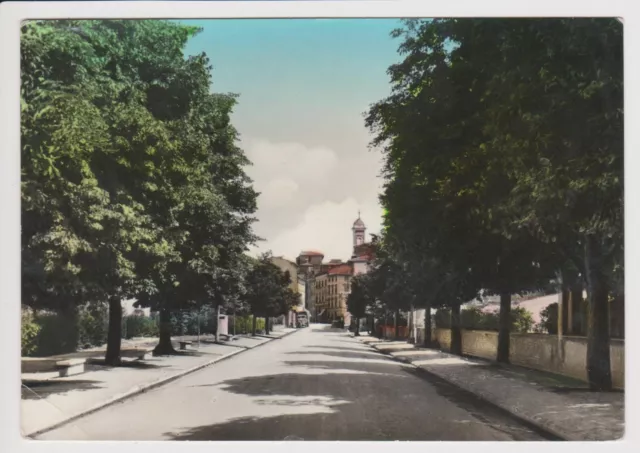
[360,336,624,441]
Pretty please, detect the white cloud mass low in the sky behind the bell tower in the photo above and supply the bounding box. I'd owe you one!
[242,140,382,259]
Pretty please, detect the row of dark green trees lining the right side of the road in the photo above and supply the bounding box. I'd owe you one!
[352,19,624,390]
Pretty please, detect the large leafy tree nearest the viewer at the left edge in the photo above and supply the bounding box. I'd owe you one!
[21,21,170,363]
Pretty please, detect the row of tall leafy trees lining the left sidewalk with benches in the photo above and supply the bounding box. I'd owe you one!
[21,20,296,364]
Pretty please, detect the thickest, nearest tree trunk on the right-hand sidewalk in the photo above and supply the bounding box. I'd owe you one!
[585,236,613,391]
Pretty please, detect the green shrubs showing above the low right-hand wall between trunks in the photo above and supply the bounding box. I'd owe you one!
[435,307,534,333]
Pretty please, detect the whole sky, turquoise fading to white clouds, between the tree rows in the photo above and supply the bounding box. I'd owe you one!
[182,19,399,259]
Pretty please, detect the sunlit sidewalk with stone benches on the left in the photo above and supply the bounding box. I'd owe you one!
[20,328,296,436]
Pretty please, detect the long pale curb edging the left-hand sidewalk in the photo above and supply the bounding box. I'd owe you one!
[23,329,300,440]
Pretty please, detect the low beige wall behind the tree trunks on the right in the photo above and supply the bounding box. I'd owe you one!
[433,329,624,389]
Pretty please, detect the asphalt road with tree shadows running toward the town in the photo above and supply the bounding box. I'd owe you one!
[38,326,544,441]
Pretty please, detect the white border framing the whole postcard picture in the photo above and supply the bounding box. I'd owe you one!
[0,0,640,453]
